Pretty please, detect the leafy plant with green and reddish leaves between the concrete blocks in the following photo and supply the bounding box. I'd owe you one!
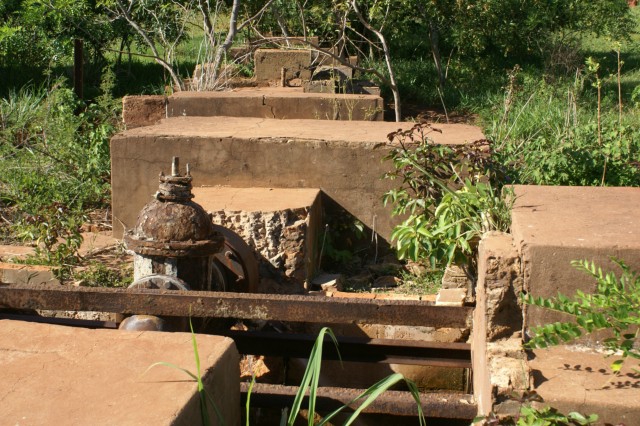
[384,124,510,267]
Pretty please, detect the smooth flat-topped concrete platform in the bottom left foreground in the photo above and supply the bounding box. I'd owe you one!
[0,320,240,426]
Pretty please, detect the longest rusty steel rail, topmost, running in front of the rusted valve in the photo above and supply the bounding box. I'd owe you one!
[0,284,472,328]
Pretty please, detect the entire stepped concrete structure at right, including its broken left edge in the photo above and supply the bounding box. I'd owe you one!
[472,186,640,425]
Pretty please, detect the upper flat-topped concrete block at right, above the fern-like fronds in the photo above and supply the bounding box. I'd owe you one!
[511,186,640,327]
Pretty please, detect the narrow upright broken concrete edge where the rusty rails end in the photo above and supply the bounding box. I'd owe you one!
[471,232,531,416]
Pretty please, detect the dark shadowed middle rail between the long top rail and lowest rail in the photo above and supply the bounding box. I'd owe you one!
[222,330,471,368]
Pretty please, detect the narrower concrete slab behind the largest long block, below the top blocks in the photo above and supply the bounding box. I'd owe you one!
[168,87,384,121]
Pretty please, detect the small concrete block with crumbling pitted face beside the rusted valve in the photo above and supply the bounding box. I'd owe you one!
[192,187,322,293]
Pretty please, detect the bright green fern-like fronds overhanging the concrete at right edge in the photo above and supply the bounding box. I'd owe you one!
[522,260,640,372]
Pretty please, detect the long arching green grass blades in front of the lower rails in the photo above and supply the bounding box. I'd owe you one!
[286,327,426,426]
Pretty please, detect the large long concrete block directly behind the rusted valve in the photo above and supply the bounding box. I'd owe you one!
[111,117,483,238]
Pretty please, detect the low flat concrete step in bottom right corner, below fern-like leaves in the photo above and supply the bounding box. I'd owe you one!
[529,346,640,426]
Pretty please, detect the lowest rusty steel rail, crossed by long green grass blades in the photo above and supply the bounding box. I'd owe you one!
[240,382,477,420]
